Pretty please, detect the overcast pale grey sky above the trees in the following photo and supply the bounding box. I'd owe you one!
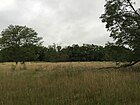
[0,0,140,45]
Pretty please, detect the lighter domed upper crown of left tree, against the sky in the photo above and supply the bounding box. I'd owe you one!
[0,25,42,49]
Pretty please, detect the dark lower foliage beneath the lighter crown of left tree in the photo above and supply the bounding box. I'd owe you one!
[1,45,42,62]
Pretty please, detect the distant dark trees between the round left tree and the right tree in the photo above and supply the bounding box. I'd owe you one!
[34,44,132,62]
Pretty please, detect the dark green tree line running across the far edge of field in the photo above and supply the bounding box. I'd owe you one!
[0,43,134,62]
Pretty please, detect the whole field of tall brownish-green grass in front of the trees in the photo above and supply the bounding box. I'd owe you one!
[0,62,140,105]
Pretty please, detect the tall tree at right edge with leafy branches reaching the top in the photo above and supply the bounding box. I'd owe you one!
[100,0,140,64]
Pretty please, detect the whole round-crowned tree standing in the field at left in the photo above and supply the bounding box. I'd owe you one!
[0,25,42,63]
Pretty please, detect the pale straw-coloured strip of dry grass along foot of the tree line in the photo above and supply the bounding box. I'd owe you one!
[0,62,116,70]
